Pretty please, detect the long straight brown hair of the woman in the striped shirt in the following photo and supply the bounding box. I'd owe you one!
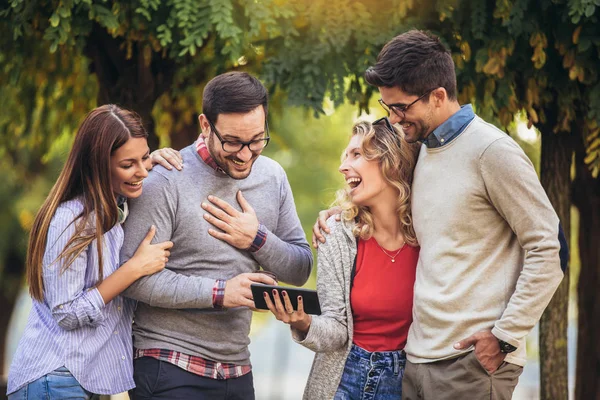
[26,104,148,301]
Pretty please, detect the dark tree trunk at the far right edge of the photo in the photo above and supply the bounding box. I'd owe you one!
[573,132,600,400]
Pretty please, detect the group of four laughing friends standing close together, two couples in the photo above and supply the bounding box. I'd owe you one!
[8,30,568,400]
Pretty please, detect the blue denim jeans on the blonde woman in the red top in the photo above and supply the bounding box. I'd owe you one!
[334,344,406,400]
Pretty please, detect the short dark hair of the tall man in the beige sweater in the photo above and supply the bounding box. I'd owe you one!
[365,29,456,102]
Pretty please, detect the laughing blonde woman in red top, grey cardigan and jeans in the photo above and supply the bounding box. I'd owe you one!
[265,118,419,400]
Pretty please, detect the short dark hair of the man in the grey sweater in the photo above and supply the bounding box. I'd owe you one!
[202,71,268,124]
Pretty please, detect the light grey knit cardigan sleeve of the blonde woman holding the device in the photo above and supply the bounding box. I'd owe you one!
[292,219,350,352]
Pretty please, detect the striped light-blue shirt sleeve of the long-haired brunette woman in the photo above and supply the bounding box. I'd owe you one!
[42,207,105,330]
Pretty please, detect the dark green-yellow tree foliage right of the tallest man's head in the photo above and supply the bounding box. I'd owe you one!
[419,0,600,176]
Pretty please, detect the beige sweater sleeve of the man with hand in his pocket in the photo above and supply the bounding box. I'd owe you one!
[480,137,563,346]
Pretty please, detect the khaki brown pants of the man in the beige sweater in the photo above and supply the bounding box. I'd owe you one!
[402,351,523,400]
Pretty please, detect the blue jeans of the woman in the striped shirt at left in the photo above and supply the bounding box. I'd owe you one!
[8,367,99,400]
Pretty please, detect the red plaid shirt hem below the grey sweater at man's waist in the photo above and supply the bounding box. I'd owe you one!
[133,349,252,380]
